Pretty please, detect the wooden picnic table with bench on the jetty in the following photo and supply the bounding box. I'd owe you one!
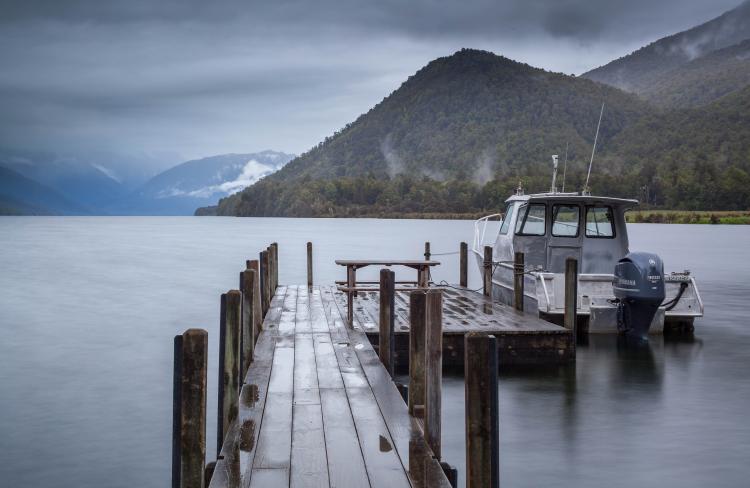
[336,259,440,326]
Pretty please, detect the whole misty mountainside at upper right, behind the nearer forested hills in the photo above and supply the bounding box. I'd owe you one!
[582,1,750,107]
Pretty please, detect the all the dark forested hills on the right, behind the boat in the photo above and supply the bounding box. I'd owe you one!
[209,2,750,216]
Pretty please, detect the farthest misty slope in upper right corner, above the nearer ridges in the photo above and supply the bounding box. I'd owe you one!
[583,1,750,99]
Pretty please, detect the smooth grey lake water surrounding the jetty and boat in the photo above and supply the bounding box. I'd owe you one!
[0,217,750,488]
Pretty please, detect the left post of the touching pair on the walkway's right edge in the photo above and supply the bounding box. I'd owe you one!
[409,290,427,418]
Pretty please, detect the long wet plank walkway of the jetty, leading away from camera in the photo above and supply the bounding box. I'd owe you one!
[210,286,450,488]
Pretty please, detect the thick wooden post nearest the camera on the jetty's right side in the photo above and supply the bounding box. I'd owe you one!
[464,332,500,488]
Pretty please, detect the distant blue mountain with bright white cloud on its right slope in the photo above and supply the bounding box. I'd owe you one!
[107,151,294,215]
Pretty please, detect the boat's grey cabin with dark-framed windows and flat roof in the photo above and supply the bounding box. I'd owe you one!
[495,193,638,274]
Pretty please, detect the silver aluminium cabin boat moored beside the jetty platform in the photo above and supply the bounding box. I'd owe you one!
[472,184,703,334]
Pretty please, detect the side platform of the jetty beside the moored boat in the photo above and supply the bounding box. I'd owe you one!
[336,286,575,366]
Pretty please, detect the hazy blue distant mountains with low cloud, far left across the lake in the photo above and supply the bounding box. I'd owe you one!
[0,151,294,215]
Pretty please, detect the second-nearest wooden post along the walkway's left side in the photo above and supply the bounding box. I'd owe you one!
[216,294,241,456]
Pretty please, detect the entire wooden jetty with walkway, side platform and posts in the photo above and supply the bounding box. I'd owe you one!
[172,243,575,488]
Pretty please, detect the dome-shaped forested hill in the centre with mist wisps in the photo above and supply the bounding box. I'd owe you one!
[209,49,650,215]
